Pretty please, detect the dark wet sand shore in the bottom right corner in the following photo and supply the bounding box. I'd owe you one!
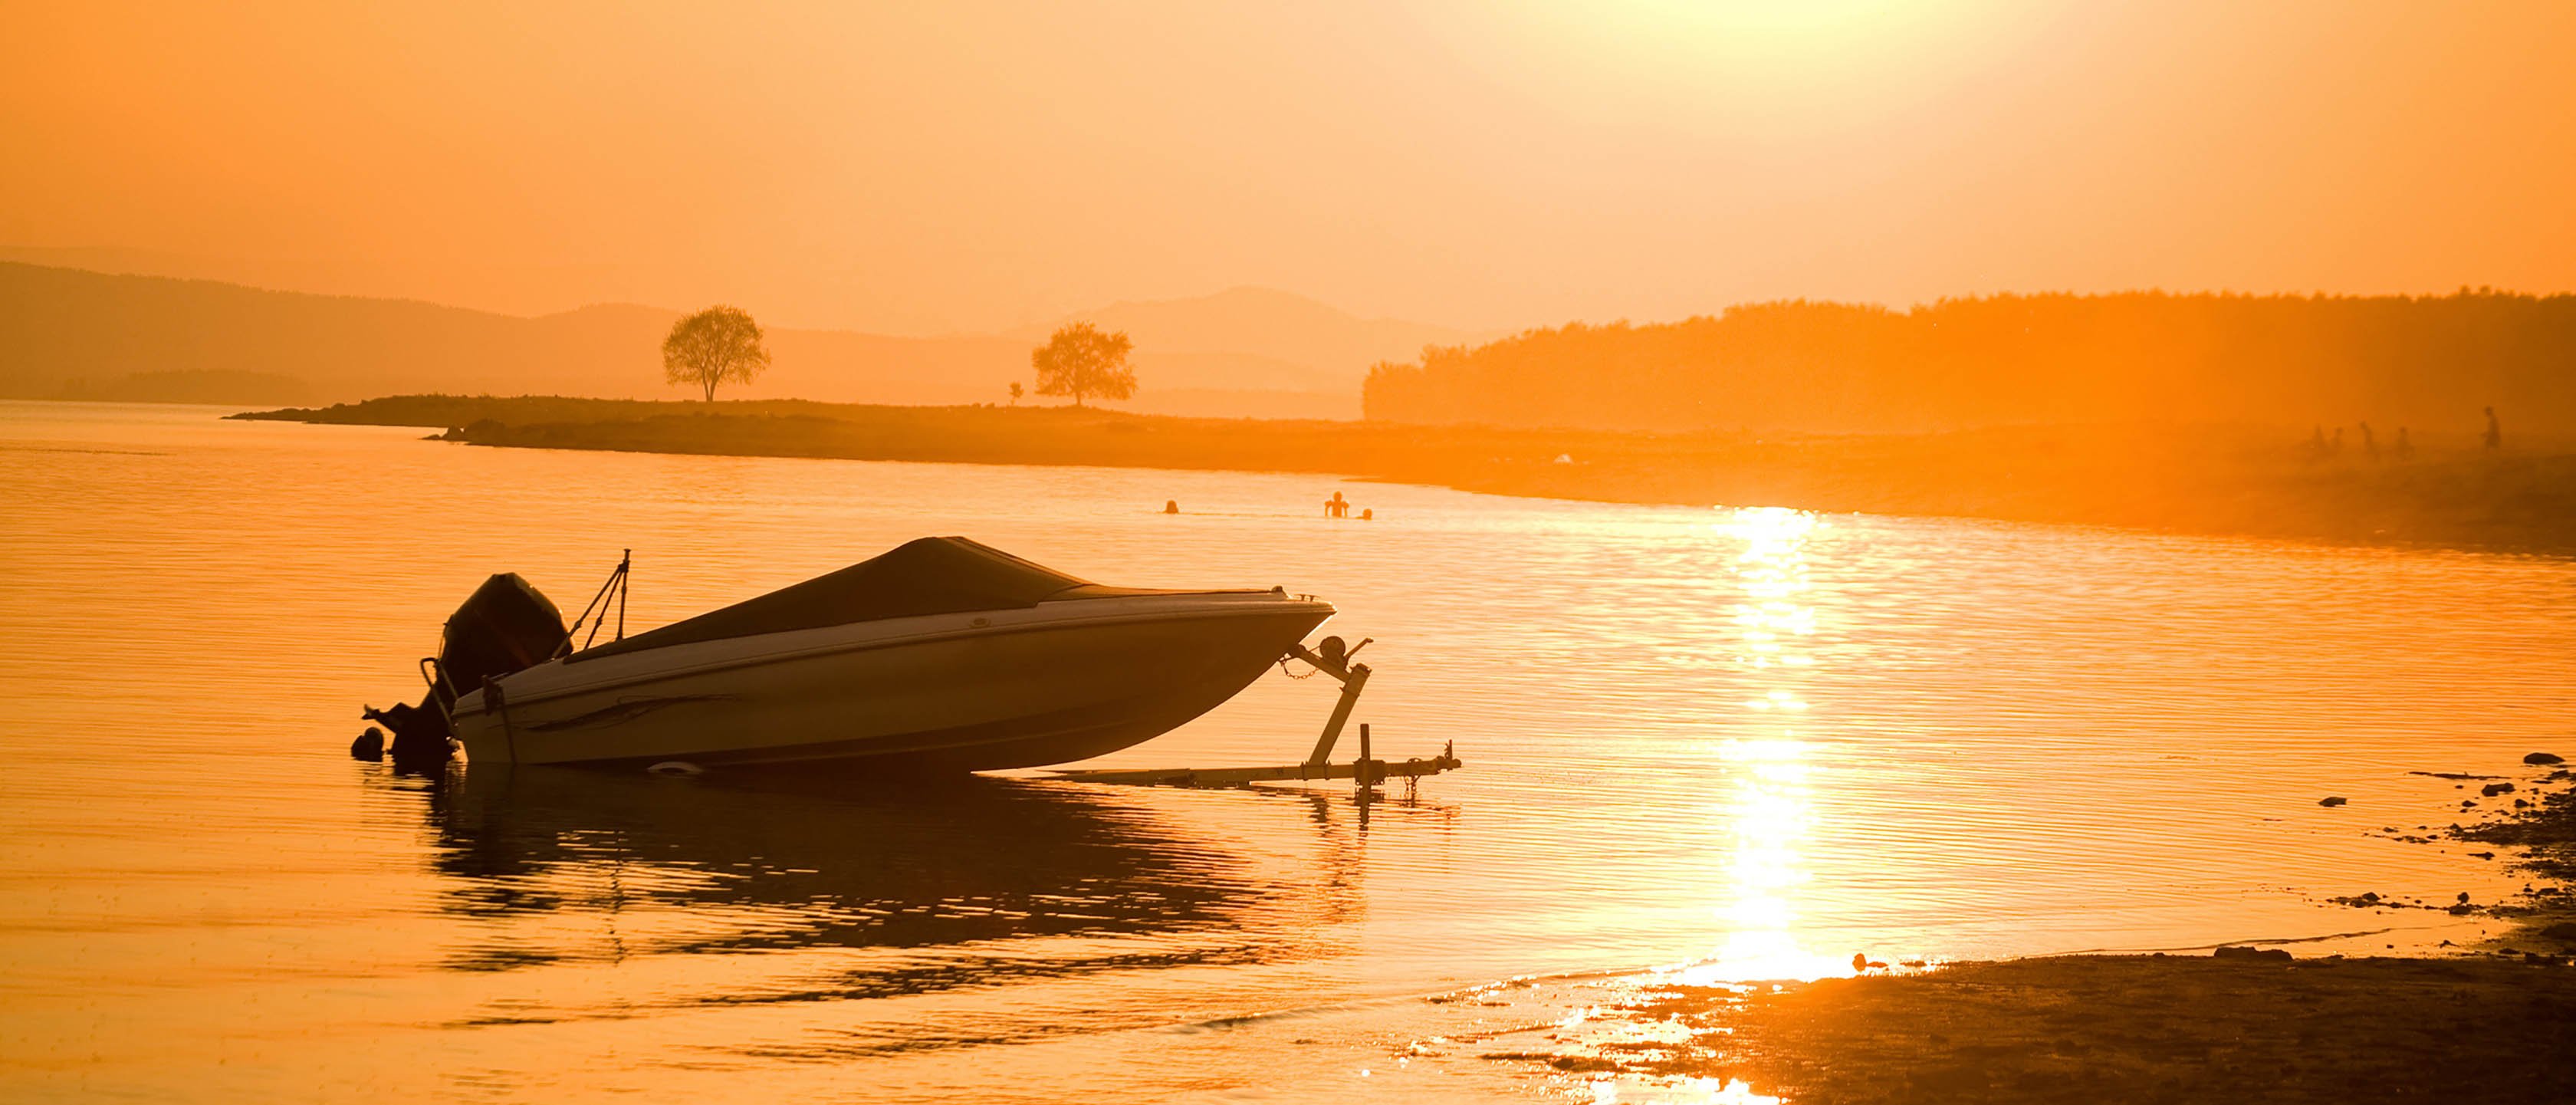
[1491,955,2576,1103]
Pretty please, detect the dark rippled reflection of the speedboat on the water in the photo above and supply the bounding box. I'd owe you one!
[406,765,1360,1041]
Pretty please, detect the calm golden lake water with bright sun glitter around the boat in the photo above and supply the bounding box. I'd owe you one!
[0,404,2576,1103]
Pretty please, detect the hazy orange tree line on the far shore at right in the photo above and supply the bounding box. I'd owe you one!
[1365,288,2576,436]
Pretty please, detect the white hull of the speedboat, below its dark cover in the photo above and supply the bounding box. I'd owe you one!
[456,593,1332,773]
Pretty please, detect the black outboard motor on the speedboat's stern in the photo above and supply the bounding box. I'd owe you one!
[350,572,572,768]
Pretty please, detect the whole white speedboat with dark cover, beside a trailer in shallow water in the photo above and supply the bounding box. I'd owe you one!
[383,538,1332,773]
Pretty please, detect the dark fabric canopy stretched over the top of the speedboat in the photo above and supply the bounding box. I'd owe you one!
[572,538,1179,662]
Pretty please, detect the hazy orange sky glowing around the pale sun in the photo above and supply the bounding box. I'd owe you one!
[0,0,2576,332]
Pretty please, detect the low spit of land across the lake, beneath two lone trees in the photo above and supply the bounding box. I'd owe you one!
[237,396,2576,554]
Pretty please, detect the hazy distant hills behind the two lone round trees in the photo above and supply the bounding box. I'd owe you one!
[0,263,1471,417]
